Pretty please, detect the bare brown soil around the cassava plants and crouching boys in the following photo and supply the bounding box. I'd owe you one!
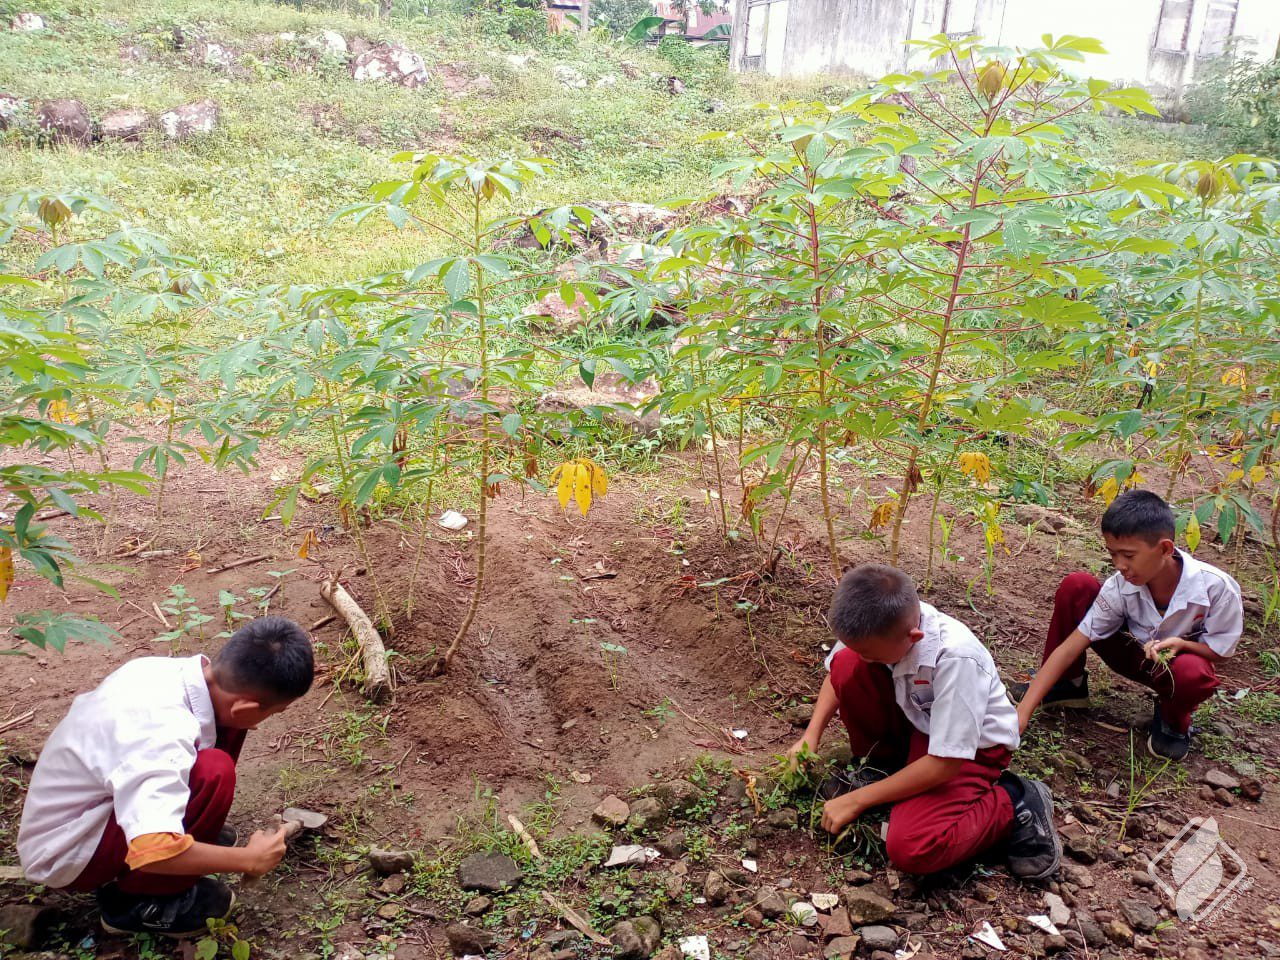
[0,437,1280,957]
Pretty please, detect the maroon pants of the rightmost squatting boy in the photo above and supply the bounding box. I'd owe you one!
[1044,572,1217,733]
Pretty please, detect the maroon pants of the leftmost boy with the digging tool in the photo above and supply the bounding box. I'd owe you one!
[67,727,246,896]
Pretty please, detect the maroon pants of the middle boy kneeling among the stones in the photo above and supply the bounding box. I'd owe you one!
[831,650,1014,873]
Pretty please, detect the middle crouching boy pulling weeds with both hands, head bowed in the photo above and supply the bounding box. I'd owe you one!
[791,563,1062,879]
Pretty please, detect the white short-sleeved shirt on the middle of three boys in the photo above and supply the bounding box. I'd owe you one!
[827,603,1020,760]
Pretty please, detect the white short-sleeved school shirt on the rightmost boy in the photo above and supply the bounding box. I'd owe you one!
[1080,550,1244,657]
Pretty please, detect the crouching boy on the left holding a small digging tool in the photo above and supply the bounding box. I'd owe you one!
[18,617,314,937]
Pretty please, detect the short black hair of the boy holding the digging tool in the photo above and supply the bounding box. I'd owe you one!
[212,617,315,707]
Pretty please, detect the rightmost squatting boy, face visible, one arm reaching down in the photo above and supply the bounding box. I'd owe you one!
[1014,490,1244,760]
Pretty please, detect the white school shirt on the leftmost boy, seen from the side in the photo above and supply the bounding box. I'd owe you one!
[18,657,218,887]
